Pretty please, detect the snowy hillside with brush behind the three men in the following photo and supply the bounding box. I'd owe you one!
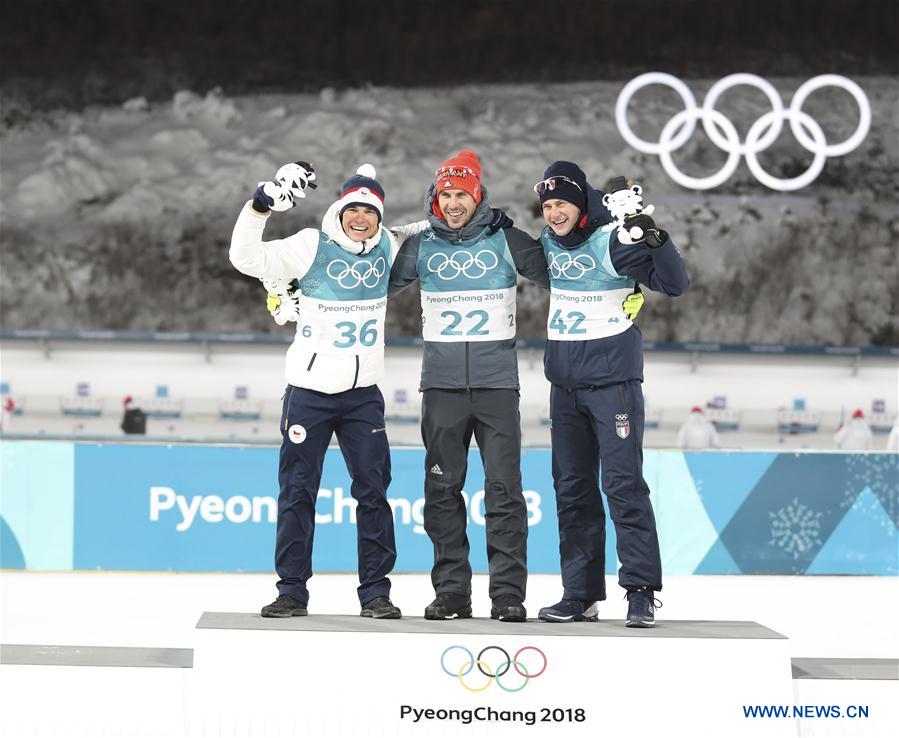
[0,78,899,345]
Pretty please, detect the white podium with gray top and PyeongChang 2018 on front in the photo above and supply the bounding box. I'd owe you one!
[189,612,797,738]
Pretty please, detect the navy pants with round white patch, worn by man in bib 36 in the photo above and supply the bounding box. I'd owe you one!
[275,385,396,604]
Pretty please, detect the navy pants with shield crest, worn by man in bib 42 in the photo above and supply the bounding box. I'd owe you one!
[550,380,662,602]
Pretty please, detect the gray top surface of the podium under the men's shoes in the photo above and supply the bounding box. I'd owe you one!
[197,612,786,639]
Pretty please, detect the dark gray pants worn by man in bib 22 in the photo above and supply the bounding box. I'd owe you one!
[421,389,528,600]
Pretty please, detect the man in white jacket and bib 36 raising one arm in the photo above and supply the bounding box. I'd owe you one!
[230,162,414,618]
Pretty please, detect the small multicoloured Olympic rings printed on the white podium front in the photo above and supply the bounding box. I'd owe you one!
[440,646,547,692]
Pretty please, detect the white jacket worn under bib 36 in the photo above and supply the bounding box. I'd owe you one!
[229,202,420,394]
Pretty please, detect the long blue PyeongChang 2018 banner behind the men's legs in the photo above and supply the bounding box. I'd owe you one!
[0,441,899,575]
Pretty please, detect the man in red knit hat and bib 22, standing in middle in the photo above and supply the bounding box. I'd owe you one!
[389,151,549,622]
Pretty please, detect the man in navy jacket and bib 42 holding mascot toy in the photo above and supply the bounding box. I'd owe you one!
[535,161,689,627]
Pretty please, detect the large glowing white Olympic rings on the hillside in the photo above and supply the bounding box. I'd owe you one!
[615,72,871,192]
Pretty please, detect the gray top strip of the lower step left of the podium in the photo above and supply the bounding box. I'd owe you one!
[0,643,194,669]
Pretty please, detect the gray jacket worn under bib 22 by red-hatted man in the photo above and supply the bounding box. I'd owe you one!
[388,185,549,390]
